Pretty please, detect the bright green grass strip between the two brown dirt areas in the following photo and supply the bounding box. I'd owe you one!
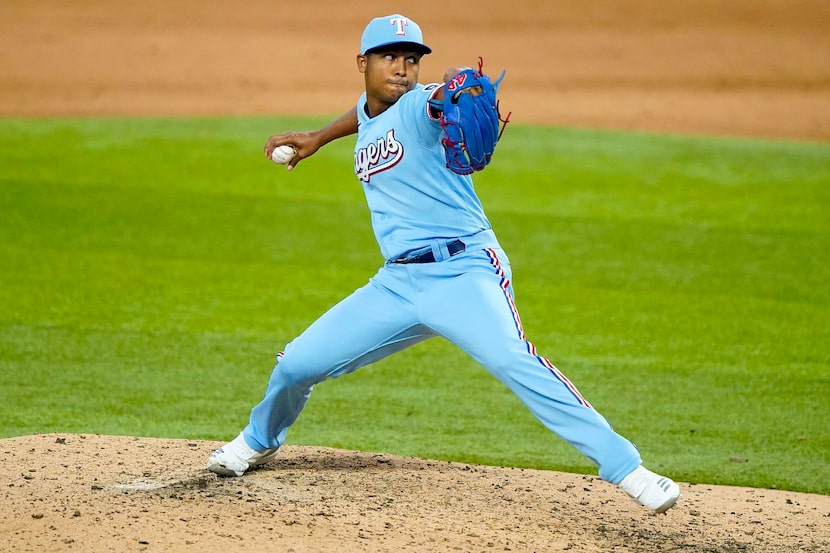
[0,114,830,494]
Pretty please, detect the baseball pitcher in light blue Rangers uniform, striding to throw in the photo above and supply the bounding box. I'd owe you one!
[208,14,680,512]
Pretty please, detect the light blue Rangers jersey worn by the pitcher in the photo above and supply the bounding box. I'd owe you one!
[354,84,490,259]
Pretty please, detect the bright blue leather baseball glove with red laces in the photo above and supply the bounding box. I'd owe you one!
[433,58,510,175]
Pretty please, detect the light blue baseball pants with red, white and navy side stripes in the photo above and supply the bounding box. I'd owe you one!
[244,231,641,483]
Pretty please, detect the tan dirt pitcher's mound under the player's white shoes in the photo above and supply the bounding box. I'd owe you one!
[0,434,830,553]
